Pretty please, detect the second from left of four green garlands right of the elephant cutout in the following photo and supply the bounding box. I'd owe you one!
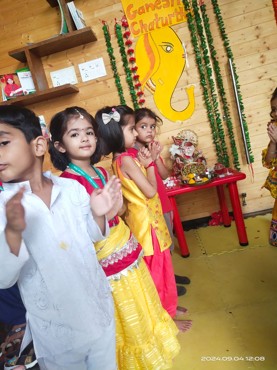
[192,0,230,167]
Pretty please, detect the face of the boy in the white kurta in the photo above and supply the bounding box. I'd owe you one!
[0,123,36,182]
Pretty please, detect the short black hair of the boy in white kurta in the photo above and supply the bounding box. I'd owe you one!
[0,105,42,143]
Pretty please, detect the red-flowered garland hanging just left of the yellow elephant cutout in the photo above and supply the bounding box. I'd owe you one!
[121,16,145,106]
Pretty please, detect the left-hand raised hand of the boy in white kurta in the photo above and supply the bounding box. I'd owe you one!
[6,188,26,233]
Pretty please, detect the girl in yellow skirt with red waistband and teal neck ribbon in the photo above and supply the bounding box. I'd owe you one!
[49,107,180,370]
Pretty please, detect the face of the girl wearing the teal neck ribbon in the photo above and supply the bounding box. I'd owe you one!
[59,117,97,160]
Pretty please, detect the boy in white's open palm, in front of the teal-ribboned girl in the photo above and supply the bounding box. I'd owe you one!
[90,176,122,217]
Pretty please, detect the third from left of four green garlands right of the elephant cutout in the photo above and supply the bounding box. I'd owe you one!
[200,3,240,170]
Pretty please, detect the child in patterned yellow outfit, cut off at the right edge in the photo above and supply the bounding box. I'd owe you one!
[262,88,277,247]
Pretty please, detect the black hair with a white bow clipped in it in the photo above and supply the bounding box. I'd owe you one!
[95,105,134,155]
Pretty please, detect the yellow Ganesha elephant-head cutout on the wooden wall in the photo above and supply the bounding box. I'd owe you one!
[135,27,195,121]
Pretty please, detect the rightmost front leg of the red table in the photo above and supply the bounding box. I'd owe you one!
[228,182,248,246]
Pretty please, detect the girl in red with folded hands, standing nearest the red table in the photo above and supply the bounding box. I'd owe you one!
[133,108,190,294]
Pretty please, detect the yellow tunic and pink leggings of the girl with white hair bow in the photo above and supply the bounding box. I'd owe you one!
[113,153,178,317]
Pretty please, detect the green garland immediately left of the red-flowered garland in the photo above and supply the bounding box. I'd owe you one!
[115,22,139,109]
